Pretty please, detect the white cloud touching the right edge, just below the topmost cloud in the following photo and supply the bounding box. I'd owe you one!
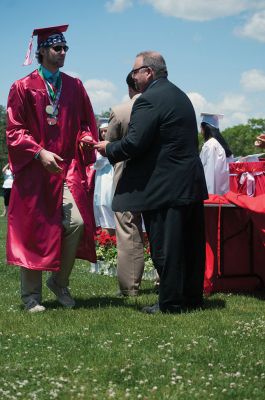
[235,10,265,42]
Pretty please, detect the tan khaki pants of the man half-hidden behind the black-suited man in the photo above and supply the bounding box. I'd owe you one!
[115,211,144,295]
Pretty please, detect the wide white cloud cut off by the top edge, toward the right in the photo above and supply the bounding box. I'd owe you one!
[142,0,265,21]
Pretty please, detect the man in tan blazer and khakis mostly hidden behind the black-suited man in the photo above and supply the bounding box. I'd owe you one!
[106,73,144,296]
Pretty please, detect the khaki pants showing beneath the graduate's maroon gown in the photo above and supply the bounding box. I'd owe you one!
[21,183,84,308]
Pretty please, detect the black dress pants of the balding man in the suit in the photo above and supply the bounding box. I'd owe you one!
[142,202,205,312]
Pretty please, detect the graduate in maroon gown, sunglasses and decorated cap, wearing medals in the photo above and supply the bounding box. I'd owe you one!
[7,25,98,312]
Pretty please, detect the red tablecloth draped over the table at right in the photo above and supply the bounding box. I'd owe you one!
[204,192,265,293]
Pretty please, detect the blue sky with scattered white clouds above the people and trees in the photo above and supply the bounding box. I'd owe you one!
[0,0,265,129]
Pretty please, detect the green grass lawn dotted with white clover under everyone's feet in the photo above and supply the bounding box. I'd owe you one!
[0,218,265,400]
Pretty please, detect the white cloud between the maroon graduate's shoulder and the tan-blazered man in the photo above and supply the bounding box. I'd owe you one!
[84,79,117,113]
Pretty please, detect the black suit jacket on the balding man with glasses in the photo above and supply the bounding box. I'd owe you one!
[106,78,207,211]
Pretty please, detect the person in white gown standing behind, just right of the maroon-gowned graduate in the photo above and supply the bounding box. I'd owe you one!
[94,123,115,234]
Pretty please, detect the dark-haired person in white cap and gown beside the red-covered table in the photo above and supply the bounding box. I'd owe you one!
[200,113,233,195]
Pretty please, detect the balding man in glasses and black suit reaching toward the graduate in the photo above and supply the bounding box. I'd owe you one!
[95,51,207,314]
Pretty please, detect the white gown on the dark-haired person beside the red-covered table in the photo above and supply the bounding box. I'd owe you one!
[200,138,229,194]
